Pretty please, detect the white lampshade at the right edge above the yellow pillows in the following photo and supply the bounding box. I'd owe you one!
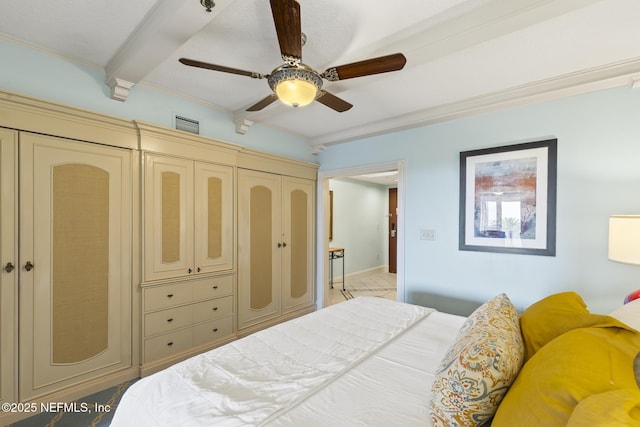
[609,215,640,264]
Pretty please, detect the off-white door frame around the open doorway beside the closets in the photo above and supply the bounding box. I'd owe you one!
[316,161,405,308]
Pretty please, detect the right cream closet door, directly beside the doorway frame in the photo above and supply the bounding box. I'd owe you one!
[282,177,315,313]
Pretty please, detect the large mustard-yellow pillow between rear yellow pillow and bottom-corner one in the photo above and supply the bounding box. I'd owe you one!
[492,319,640,427]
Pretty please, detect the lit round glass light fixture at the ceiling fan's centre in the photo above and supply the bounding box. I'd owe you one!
[267,64,322,107]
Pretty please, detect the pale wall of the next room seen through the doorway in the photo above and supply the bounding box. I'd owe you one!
[329,178,389,277]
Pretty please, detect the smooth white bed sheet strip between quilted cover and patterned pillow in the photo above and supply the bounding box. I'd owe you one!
[265,312,466,427]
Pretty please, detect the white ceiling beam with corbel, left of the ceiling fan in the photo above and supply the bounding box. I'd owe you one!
[105,0,236,101]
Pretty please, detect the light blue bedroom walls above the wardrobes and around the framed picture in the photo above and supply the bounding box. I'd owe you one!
[6,36,640,312]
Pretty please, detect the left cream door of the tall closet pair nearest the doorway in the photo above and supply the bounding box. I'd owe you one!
[238,170,282,328]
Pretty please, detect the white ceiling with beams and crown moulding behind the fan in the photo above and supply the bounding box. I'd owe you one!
[0,0,640,151]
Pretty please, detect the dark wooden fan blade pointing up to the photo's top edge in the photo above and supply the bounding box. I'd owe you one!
[271,0,302,63]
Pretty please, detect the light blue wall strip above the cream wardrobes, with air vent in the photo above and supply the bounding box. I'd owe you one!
[0,39,318,163]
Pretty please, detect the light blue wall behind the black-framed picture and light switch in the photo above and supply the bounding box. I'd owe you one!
[320,88,640,313]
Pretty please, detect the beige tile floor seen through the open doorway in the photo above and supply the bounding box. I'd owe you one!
[329,273,397,305]
